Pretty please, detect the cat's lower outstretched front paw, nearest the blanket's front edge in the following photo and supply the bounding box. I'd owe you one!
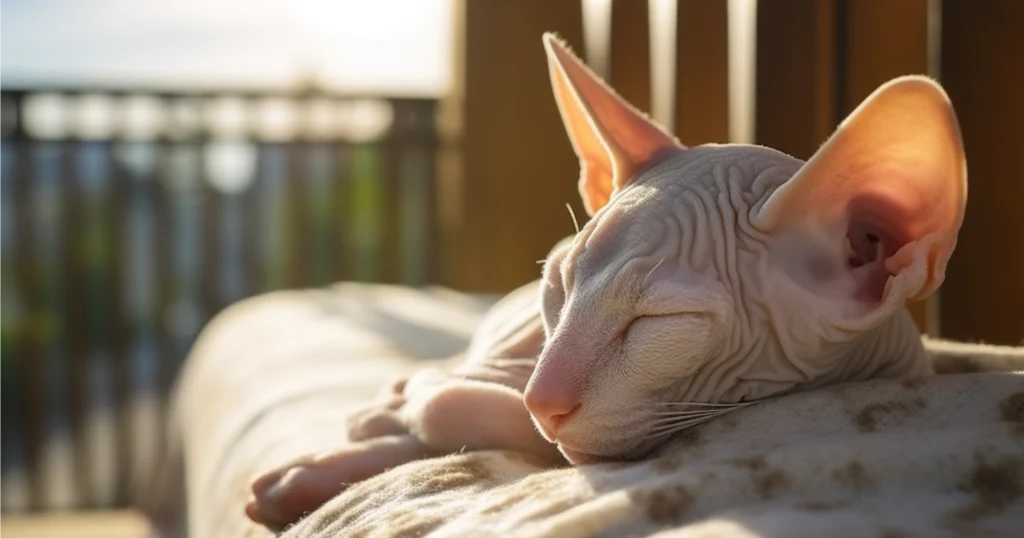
[246,434,436,532]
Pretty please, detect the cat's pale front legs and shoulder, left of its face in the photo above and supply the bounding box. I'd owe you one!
[246,282,563,529]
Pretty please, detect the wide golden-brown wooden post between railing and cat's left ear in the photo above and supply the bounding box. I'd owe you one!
[442,0,586,291]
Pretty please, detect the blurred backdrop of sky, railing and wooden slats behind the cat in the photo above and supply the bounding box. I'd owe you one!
[0,0,1024,536]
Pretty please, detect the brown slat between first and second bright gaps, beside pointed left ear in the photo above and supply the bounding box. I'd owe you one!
[608,0,651,113]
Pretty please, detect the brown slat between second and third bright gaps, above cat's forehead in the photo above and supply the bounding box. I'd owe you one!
[675,0,729,146]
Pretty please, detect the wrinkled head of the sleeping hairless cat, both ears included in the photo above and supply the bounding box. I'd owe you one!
[524,34,967,462]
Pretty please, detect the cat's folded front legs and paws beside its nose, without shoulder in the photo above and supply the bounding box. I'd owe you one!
[246,369,563,530]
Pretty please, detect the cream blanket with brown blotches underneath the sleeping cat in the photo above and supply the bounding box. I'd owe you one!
[148,285,1024,538]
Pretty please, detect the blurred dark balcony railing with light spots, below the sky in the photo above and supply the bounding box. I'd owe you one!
[0,88,436,512]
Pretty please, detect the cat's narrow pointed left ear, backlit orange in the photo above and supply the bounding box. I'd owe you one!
[544,33,682,215]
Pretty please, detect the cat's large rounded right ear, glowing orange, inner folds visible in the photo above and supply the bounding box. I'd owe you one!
[753,76,967,327]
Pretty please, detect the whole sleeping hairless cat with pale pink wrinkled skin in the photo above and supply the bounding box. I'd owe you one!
[247,34,967,528]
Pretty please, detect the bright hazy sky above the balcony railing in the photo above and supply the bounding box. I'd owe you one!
[0,0,452,95]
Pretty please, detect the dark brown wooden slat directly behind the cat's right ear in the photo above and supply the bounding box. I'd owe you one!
[838,0,938,334]
